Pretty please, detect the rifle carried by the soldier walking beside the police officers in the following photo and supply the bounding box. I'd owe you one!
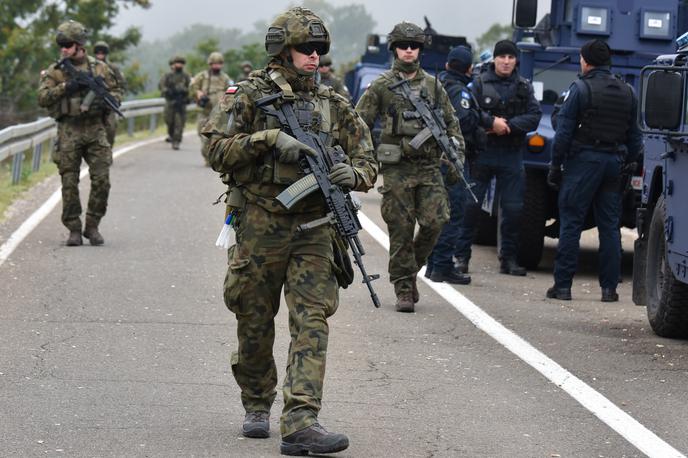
[389,77,478,203]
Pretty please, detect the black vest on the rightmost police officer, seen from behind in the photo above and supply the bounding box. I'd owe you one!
[574,73,633,148]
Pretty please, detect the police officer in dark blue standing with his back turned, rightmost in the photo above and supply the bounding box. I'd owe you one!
[546,39,643,302]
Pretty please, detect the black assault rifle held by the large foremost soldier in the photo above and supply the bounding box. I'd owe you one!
[256,92,380,307]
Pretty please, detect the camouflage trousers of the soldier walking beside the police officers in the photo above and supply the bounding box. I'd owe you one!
[378,171,449,295]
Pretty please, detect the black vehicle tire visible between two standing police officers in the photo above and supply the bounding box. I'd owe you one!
[518,170,548,270]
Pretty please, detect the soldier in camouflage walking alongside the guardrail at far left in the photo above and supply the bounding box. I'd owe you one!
[38,21,121,246]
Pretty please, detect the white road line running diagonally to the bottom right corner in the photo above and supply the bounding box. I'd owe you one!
[358,212,685,458]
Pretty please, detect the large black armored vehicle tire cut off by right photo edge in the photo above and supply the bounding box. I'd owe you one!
[645,197,688,338]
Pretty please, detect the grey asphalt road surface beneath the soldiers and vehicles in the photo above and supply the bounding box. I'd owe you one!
[0,134,688,457]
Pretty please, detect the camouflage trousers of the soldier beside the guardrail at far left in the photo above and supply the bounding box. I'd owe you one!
[53,118,112,231]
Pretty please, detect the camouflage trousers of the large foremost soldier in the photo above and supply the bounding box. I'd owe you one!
[224,204,339,436]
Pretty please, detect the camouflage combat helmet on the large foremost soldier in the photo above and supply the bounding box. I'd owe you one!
[265,7,330,57]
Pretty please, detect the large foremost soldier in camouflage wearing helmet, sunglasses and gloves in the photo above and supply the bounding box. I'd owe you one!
[204,8,377,455]
